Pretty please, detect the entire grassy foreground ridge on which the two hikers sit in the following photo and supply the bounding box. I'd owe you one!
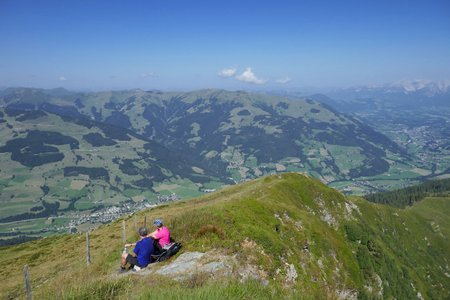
[0,173,450,299]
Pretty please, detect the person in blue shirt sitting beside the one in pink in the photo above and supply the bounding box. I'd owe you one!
[120,227,154,272]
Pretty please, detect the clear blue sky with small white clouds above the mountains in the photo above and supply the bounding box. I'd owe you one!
[0,0,450,90]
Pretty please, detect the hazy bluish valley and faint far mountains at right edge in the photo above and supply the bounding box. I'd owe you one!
[302,80,450,176]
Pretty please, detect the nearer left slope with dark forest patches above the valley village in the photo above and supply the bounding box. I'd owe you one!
[0,108,221,244]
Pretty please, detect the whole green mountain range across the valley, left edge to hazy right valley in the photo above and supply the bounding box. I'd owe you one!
[0,88,442,241]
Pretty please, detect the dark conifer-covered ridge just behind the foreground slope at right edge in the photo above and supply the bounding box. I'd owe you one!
[364,178,450,208]
